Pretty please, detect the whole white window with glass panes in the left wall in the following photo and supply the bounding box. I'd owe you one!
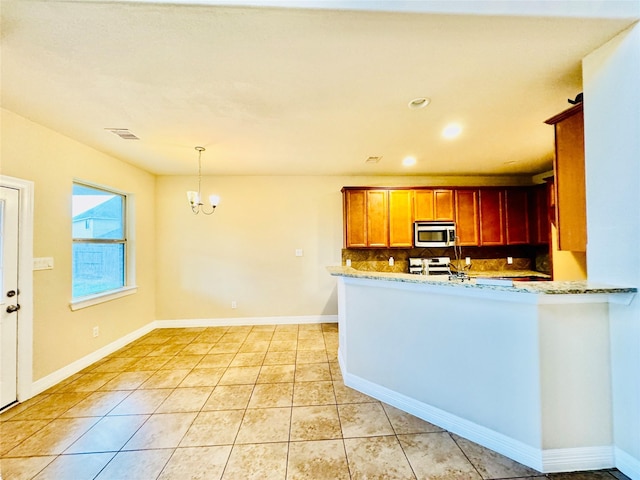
[72,182,134,310]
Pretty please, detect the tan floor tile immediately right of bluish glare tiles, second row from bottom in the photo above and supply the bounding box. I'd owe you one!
[180,410,244,447]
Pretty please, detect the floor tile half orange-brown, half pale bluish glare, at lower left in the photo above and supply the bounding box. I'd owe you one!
[7,417,99,457]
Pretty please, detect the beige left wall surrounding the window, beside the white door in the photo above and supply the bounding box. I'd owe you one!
[0,110,155,381]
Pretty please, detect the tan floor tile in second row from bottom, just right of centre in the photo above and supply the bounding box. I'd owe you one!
[338,403,394,438]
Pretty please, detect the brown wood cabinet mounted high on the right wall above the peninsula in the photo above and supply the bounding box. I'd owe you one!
[545,103,587,252]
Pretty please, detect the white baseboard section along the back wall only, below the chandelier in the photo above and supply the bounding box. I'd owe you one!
[154,315,338,328]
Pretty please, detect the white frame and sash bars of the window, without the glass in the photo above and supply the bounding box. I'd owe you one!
[69,178,138,311]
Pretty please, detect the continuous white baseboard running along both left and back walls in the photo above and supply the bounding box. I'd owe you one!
[31,315,338,400]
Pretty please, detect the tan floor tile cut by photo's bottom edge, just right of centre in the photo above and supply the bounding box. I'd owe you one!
[344,436,418,480]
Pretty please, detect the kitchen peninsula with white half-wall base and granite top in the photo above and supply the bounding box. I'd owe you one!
[328,267,637,472]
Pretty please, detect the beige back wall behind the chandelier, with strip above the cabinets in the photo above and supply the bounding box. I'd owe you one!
[156,172,523,320]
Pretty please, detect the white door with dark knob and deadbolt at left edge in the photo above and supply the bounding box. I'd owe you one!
[0,187,20,410]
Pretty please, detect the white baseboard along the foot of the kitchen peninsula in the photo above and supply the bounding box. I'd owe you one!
[338,368,616,472]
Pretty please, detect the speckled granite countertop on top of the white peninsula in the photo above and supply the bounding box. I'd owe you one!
[327,266,638,295]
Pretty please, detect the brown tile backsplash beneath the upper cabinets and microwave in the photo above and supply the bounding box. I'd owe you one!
[342,246,549,273]
